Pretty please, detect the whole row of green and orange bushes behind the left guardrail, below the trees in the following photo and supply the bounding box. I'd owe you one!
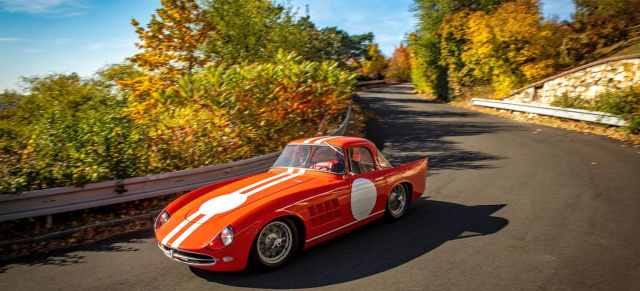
[0,53,357,194]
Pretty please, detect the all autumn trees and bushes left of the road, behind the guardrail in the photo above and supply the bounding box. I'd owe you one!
[0,0,418,194]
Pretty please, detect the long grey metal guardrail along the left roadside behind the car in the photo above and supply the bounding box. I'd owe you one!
[0,105,351,221]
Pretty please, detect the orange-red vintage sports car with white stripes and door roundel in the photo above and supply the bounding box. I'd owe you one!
[155,136,427,271]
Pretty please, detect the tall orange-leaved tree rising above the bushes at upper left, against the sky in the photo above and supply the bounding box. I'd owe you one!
[118,0,217,118]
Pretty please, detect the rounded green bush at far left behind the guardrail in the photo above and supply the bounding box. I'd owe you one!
[0,74,146,193]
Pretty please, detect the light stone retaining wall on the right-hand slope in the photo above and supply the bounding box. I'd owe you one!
[502,54,640,105]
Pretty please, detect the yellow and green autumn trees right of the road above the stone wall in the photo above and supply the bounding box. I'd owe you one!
[408,0,640,101]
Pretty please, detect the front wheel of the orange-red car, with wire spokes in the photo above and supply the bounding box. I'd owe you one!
[250,218,298,271]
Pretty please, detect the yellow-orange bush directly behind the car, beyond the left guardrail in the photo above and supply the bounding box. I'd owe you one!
[134,53,357,171]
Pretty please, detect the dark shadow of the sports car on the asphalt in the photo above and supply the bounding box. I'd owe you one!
[191,198,508,289]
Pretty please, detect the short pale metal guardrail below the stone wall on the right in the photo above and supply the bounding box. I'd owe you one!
[471,98,628,126]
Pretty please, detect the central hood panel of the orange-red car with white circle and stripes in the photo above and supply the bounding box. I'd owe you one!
[185,170,314,224]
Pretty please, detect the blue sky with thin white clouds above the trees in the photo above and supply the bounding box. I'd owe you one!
[0,0,574,92]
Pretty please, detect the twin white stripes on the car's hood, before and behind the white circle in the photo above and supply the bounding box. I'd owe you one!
[162,169,305,248]
